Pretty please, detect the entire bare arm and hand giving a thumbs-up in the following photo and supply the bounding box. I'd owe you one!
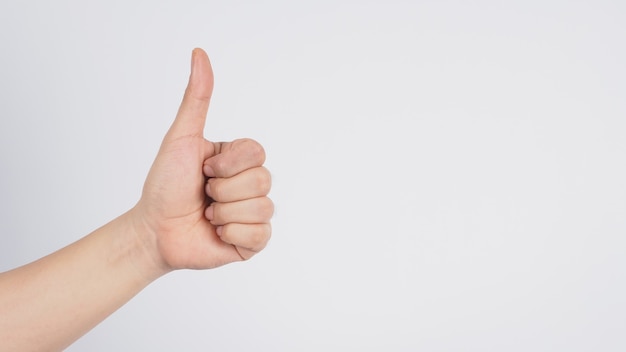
[0,49,273,351]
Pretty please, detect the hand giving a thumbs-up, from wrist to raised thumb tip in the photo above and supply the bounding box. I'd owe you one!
[131,49,273,274]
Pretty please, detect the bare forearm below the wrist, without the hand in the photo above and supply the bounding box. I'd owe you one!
[0,210,161,351]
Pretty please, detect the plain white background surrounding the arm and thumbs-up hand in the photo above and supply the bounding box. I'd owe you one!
[0,0,626,351]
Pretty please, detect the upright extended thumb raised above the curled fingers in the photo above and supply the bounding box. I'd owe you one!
[167,48,213,139]
